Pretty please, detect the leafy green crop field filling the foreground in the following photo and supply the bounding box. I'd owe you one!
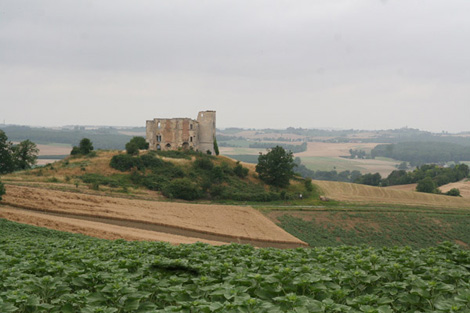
[0,219,470,313]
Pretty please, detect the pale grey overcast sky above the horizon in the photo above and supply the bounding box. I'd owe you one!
[0,0,470,132]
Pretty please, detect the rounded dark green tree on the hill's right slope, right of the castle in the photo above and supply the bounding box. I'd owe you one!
[256,146,295,187]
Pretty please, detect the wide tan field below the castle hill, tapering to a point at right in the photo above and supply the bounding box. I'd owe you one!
[2,185,306,247]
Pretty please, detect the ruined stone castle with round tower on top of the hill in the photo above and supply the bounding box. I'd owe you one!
[146,111,215,154]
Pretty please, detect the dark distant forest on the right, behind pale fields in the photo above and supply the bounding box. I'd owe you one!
[371,142,470,166]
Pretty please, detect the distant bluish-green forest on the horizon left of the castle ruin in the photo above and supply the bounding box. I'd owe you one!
[2,126,132,150]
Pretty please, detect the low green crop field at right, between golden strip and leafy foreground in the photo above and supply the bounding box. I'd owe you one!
[268,208,470,249]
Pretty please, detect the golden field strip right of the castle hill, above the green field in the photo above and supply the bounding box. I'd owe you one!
[313,180,470,208]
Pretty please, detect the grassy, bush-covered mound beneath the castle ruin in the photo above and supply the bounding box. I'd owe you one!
[2,151,318,202]
